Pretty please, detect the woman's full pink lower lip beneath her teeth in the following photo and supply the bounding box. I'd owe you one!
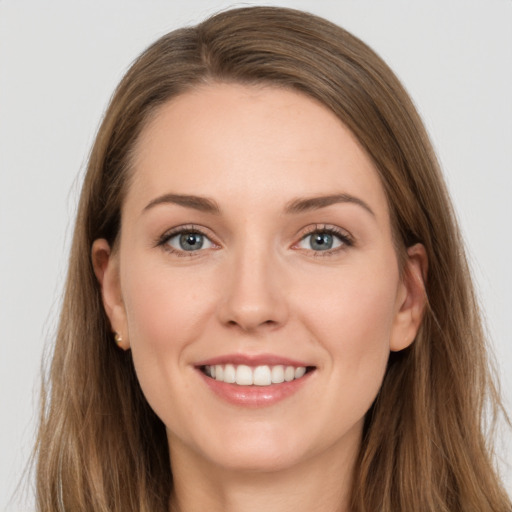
[198,370,314,407]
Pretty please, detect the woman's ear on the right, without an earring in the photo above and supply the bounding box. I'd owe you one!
[389,244,428,352]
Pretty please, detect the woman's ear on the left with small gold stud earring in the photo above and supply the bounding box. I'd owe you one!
[91,238,130,350]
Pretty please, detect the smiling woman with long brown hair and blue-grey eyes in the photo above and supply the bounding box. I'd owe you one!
[34,7,510,511]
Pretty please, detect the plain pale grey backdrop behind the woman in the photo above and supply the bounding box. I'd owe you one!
[0,0,512,512]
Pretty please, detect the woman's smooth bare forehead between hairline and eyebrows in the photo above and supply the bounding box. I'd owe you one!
[127,84,387,220]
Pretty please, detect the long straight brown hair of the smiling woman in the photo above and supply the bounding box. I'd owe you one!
[37,7,511,512]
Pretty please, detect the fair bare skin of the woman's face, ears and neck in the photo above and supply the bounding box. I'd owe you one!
[92,84,427,512]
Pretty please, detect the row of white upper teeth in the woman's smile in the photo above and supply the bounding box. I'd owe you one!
[204,364,306,386]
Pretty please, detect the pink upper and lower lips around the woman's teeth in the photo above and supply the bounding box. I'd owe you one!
[194,354,315,408]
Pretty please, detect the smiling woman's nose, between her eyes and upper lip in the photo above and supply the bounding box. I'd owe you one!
[218,243,288,332]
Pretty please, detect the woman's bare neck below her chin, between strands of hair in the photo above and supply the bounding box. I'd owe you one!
[166,432,359,512]
